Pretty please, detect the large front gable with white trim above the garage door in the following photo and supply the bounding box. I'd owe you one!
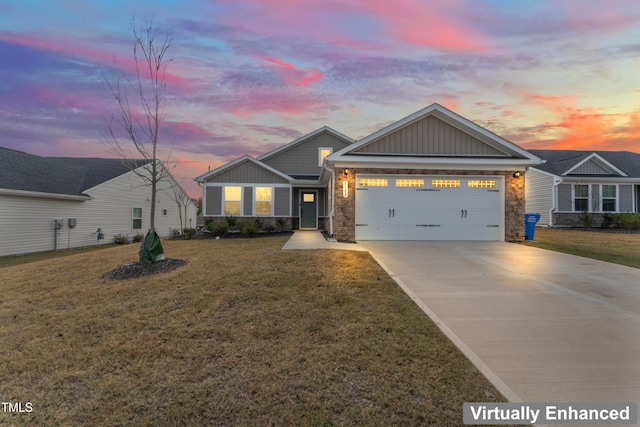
[329,103,541,165]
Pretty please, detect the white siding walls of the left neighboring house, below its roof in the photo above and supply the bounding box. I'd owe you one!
[0,172,196,256]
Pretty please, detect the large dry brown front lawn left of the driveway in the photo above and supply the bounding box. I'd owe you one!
[0,237,510,426]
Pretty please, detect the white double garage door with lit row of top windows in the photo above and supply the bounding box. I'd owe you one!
[356,175,504,240]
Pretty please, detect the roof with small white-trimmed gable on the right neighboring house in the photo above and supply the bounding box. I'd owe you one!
[529,150,640,178]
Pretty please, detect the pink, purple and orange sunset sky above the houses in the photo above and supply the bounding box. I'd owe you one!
[0,0,640,196]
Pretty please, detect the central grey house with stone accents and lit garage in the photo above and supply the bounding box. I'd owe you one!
[196,104,542,241]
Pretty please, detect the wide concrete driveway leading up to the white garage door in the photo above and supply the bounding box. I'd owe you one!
[360,242,640,402]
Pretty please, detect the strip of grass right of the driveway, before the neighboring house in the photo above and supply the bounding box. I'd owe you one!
[526,228,640,268]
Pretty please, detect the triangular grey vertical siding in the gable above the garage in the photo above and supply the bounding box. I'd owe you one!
[355,116,507,157]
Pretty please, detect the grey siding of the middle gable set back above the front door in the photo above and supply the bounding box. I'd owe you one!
[263,132,348,175]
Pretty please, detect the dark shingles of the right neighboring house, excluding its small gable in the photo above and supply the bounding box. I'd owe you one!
[529,150,640,178]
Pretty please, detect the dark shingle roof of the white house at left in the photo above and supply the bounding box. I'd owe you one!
[0,147,148,197]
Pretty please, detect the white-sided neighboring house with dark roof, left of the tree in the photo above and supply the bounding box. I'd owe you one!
[0,147,197,256]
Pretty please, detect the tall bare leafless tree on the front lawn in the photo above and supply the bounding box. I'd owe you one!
[105,19,172,231]
